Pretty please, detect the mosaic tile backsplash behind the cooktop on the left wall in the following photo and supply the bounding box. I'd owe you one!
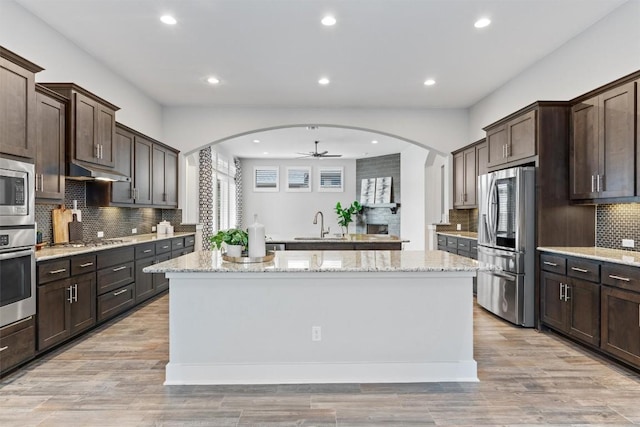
[36,180,182,242]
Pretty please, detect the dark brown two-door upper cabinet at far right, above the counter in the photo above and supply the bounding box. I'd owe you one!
[569,82,636,200]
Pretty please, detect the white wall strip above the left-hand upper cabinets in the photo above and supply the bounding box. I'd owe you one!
[0,0,163,141]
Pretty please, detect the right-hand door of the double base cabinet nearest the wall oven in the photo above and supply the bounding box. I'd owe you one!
[70,273,96,334]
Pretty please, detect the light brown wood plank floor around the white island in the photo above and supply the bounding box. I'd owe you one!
[0,295,640,427]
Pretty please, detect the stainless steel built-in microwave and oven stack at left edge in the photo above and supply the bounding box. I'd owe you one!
[0,158,36,327]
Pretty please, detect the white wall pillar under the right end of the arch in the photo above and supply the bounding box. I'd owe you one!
[400,145,429,250]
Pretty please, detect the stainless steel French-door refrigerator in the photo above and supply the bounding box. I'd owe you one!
[477,167,536,327]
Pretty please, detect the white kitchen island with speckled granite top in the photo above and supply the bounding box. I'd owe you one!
[144,251,484,385]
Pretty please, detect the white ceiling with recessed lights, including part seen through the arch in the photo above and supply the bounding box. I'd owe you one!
[17,0,625,158]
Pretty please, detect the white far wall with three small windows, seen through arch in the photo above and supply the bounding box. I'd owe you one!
[242,159,357,238]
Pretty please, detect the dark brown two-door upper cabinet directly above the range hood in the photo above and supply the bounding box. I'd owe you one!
[42,83,119,167]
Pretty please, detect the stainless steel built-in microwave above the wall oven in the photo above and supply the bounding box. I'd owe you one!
[0,158,35,226]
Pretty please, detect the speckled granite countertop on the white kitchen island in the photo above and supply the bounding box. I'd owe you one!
[143,251,495,273]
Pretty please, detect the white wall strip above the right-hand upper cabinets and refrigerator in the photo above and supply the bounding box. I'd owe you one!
[469,0,640,142]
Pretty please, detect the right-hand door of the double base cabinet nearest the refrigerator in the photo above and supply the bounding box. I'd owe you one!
[567,279,600,346]
